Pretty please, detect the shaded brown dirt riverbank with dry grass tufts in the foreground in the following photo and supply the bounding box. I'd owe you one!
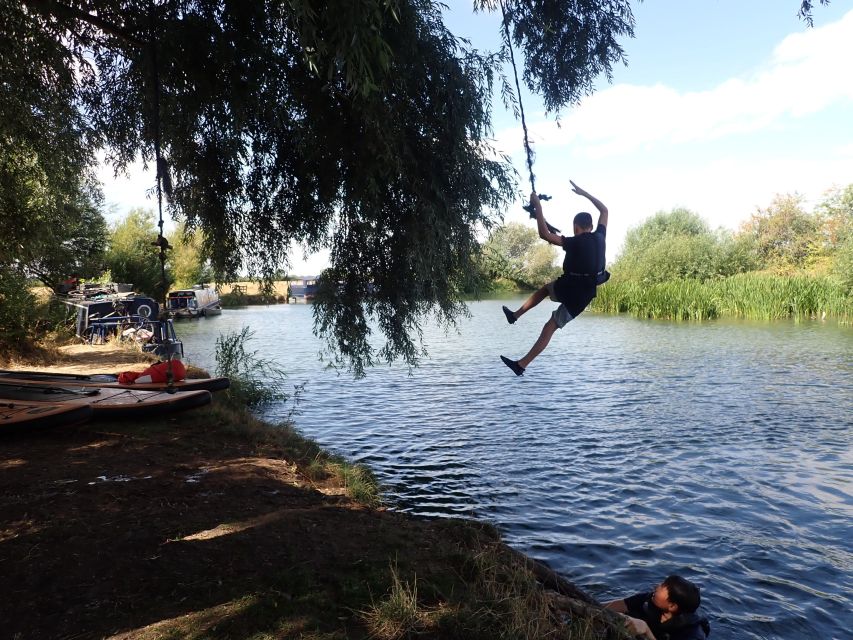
[0,347,620,640]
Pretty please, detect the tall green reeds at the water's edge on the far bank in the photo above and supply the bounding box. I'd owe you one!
[591,273,853,321]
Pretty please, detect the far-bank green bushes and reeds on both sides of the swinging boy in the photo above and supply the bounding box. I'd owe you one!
[471,184,853,319]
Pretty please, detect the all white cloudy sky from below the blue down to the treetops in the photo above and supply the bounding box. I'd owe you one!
[498,11,853,259]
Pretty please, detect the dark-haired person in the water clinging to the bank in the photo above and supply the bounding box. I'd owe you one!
[604,575,711,640]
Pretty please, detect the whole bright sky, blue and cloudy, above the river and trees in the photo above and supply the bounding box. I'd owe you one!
[102,0,853,273]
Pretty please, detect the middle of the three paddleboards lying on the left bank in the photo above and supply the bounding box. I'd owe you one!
[0,381,211,418]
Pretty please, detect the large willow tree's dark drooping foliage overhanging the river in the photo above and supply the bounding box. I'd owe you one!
[0,0,824,374]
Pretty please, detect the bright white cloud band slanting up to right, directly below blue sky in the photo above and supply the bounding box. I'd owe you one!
[498,11,853,157]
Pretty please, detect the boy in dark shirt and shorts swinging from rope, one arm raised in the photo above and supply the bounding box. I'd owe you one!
[501,180,610,376]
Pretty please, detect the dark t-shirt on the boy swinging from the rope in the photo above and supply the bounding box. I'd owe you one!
[554,224,607,318]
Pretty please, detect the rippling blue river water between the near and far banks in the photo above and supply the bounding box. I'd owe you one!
[177,301,853,640]
